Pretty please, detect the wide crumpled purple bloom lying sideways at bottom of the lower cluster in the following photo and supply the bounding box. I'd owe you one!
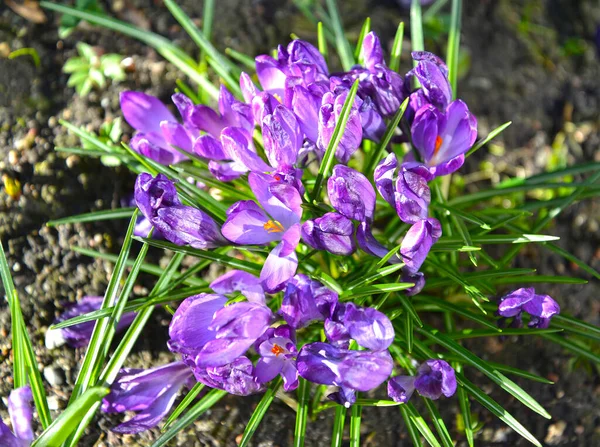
[296,342,393,391]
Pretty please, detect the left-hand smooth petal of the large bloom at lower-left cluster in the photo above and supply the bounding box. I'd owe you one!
[168,293,227,355]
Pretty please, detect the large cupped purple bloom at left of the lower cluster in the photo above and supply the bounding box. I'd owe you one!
[168,293,273,370]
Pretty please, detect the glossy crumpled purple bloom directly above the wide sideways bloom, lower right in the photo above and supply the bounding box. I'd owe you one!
[344,303,394,351]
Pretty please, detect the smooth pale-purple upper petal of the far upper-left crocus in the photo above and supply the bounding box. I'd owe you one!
[120,91,177,132]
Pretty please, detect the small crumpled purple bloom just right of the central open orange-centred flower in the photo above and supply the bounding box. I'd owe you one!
[302,213,356,256]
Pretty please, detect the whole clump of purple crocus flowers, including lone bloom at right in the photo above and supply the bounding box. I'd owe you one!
[44,32,559,433]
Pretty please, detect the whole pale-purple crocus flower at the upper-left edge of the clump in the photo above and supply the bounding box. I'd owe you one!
[120,91,198,165]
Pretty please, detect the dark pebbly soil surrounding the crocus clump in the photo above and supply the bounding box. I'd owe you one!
[0,0,600,447]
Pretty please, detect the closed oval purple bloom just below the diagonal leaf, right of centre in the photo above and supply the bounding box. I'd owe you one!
[327,165,375,222]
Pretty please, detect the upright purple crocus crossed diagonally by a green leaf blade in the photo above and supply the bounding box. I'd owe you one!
[317,90,363,163]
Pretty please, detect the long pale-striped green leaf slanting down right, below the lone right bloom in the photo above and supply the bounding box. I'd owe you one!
[415,325,551,419]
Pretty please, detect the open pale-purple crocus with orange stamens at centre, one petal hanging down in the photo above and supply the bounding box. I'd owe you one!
[221,172,302,293]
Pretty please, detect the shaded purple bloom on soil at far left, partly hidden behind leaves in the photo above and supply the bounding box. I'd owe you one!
[45,296,135,349]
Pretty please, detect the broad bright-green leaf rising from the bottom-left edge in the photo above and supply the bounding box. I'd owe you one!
[31,387,110,447]
